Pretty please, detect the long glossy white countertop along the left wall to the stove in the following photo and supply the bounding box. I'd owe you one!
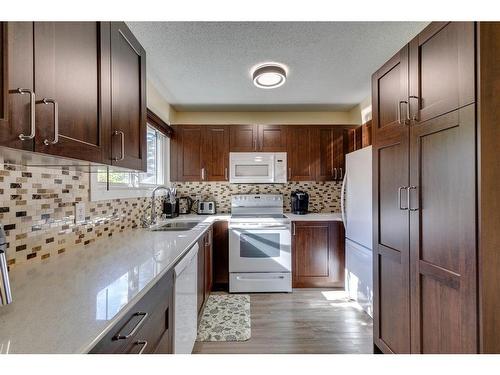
[0,215,229,353]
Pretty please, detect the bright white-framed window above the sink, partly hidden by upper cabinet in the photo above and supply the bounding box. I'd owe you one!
[90,124,170,201]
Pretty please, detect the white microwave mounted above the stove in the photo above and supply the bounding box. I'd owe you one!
[229,152,287,184]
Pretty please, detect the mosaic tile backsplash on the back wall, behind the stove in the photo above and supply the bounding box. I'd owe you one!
[176,181,342,213]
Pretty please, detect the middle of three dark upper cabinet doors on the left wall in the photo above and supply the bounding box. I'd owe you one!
[34,22,111,162]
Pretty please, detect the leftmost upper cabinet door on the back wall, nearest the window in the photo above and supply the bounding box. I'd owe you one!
[176,125,206,181]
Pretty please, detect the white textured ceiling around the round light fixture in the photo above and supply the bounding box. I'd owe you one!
[127,22,427,111]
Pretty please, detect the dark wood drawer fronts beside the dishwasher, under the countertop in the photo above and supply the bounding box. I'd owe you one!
[90,271,173,354]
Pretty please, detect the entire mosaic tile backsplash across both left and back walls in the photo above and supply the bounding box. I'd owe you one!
[0,156,340,268]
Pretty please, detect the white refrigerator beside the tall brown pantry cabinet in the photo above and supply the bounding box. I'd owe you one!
[341,146,373,316]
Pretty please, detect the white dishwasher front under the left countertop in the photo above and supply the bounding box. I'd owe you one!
[174,244,198,354]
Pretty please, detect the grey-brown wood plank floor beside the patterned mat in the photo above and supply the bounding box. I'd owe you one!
[193,289,373,354]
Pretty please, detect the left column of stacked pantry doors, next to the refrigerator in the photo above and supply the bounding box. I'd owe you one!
[372,47,410,353]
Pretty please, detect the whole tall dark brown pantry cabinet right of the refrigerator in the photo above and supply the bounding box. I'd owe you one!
[372,22,500,353]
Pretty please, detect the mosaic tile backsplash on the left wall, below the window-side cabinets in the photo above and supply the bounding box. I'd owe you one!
[0,156,158,267]
